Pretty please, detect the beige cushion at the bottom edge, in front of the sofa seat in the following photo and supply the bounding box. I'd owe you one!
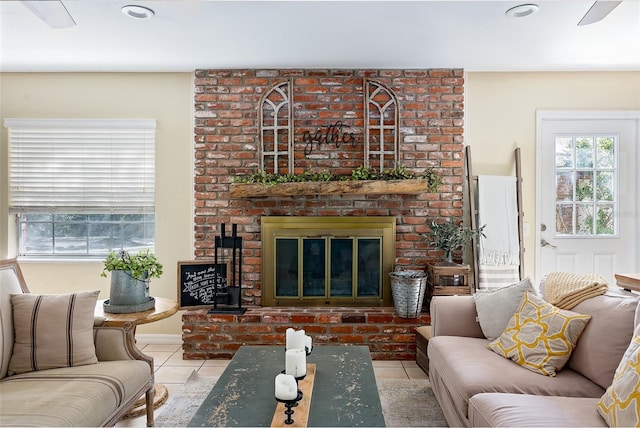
[469,393,607,427]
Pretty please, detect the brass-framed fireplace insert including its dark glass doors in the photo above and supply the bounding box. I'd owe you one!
[261,216,396,306]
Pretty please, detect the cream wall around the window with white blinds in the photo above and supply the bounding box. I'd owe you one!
[0,73,193,334]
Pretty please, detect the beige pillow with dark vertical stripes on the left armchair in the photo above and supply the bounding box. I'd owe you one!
[9,290,100,374]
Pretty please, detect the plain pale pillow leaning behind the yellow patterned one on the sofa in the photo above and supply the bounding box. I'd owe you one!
[473,278,535,340]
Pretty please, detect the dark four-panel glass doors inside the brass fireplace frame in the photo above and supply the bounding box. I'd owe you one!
[275,236,382,300]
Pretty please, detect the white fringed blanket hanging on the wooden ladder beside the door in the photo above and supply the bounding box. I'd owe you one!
[478,175,520,288]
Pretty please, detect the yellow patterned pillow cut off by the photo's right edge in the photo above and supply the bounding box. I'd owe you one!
[598,325,640,427]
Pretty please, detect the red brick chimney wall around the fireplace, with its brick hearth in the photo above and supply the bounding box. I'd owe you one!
[183,69,464,358]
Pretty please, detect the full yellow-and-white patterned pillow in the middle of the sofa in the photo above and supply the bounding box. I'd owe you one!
[487,292,591,376]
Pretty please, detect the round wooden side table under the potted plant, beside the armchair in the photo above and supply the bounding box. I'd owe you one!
[94,297,178,418]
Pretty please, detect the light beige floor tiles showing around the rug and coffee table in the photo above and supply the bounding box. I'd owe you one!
[116,342,427,427]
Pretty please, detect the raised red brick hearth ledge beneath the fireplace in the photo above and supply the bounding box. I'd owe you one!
[182,307,431,360]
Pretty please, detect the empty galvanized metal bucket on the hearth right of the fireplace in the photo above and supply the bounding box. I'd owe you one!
[389,270,427,318]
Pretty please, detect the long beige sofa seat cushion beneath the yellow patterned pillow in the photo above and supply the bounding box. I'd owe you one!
[427,336,604,426]
